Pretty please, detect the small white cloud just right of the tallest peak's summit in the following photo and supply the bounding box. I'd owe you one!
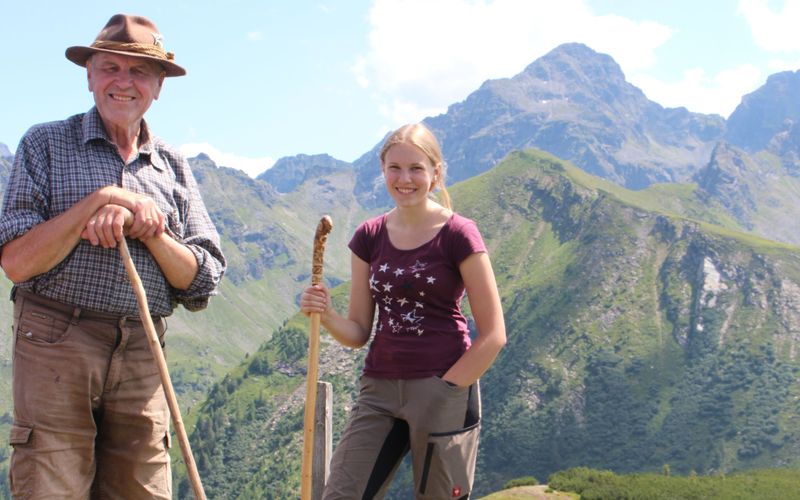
[630,64,764,118]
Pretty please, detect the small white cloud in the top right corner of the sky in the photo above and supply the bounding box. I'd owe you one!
[738,0,800,52]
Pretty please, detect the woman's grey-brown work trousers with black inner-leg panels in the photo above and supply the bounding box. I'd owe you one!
[323,376,481,500]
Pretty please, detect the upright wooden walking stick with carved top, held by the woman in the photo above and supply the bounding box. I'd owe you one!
[300,215,333,500]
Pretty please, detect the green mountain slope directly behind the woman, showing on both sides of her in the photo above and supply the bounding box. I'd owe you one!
[181,151,800,498]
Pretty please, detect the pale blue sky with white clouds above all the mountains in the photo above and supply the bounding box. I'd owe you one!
[0,0,800,176]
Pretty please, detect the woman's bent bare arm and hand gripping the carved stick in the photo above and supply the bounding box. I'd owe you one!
[300,254,375,348]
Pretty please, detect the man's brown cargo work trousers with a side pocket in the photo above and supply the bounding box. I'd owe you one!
[9,290,172,500]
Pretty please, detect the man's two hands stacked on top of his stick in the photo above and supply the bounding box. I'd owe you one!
[81,186,166,248]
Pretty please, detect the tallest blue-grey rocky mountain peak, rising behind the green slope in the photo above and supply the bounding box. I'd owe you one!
[354,43,725,206]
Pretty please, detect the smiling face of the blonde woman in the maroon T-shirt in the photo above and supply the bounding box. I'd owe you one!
[383,142,437,207]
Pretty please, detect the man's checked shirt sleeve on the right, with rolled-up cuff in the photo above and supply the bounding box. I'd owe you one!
[168,153,226,311]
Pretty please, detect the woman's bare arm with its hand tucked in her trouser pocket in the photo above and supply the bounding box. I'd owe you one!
[442,252,506,387]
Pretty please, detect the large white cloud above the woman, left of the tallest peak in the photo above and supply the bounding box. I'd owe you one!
[352,0,672,124]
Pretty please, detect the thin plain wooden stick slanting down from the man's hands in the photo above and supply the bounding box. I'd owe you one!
[119,238,206,500]
